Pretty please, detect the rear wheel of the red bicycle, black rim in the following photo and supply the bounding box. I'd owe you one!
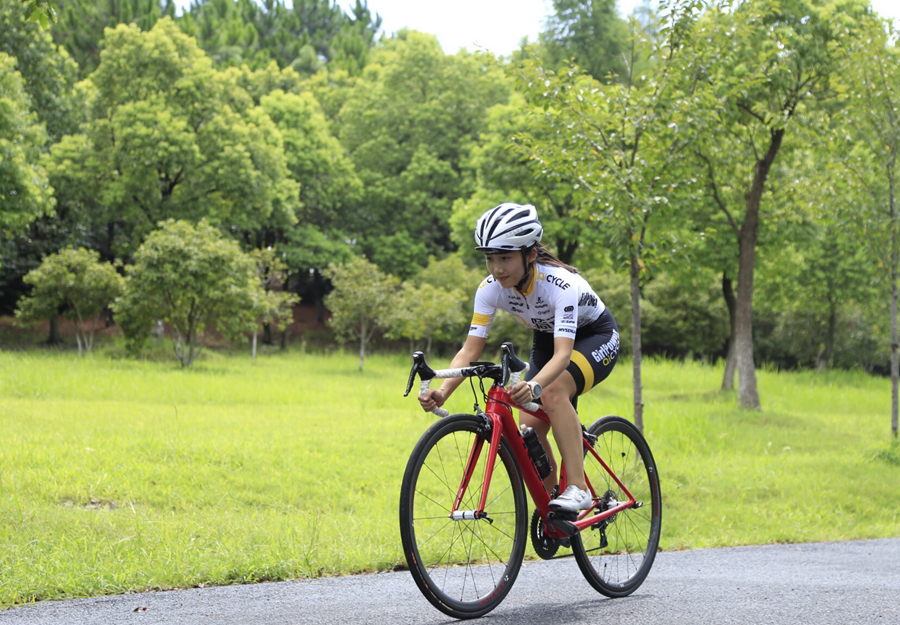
[572,417,662,597]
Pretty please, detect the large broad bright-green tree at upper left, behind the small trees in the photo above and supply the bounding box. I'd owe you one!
[48,17,299,259]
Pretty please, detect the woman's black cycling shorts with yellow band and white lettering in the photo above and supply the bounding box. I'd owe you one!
[525,308,619,403]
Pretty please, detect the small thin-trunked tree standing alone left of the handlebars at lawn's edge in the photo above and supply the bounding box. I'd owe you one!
[325,257,397,371]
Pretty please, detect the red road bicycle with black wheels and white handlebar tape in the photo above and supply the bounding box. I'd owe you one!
[400,343,662,618]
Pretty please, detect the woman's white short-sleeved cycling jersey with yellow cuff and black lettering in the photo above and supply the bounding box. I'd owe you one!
[469,263,606,339]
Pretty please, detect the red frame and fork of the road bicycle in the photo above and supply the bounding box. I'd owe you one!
[450,384,636,538]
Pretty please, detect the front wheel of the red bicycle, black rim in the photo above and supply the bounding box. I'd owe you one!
[400,414,527,618]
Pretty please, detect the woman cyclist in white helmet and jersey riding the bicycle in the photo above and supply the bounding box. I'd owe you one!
[419,202,619,512]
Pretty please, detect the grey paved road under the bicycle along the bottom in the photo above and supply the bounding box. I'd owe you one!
[0,539,900,625]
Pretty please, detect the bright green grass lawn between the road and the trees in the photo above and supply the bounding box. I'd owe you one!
[0,350,900,607]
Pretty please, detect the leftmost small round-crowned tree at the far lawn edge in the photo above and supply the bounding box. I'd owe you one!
[16,248,124,356]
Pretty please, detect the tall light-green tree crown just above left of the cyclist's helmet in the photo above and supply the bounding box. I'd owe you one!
[340,31,509,266]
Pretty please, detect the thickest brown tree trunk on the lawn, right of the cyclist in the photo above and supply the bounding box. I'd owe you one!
[734,128,784,410]
